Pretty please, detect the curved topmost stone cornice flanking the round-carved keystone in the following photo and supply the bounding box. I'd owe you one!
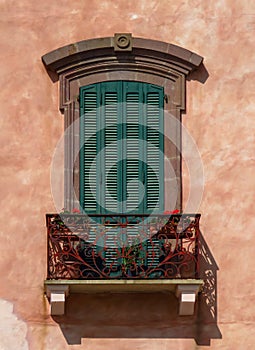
[42,34,203,76]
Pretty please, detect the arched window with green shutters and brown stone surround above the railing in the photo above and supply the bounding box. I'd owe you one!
[42,34,203,213]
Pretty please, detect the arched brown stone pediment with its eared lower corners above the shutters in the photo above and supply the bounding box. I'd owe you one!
[42,33,203,110]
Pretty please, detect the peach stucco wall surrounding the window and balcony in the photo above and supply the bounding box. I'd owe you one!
[0,0,255,350]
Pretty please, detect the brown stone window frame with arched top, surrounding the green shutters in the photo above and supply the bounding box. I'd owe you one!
[42,33,203,210]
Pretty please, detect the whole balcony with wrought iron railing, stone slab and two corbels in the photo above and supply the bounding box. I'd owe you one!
[45,213,203,315]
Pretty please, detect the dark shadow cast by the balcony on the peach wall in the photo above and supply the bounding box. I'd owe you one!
[53,231,222,345]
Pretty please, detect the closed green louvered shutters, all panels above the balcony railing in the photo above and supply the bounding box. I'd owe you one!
[80,81,164,214]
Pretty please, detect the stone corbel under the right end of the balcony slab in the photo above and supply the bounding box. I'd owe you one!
[175,284,200,316]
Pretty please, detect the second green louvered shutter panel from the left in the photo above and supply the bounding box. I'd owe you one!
[98,82,122,274]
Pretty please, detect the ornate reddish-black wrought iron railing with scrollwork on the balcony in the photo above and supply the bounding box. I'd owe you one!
[46,214,200,279]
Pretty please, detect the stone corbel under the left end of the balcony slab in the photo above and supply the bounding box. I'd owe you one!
[46,285,69,315]
